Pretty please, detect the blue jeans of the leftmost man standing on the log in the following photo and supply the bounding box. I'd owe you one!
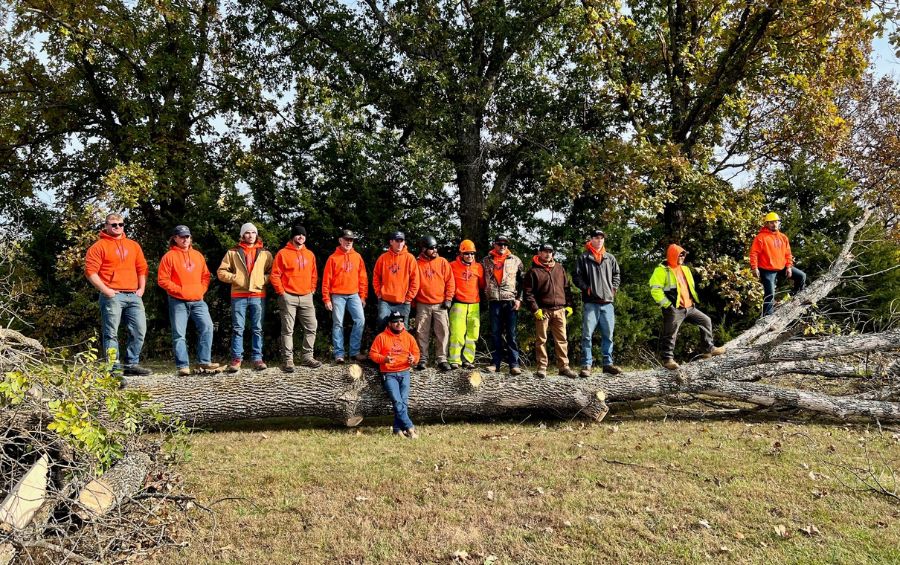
[100,292,147,369]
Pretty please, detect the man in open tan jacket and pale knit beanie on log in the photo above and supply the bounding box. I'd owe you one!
[216,222,272,373]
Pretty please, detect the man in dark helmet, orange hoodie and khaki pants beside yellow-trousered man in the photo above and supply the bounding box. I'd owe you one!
[416,235,456,371]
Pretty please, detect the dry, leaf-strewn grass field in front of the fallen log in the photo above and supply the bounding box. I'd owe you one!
[156,413,900,564]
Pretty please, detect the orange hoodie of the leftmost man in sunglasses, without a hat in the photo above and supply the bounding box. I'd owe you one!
[84,231,148,291]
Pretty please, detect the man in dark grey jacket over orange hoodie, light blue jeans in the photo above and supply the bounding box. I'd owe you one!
[574,229,622,377]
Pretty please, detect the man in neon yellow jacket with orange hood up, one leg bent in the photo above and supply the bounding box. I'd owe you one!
[650,243,725,371]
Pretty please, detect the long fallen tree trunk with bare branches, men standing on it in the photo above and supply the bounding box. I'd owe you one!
[125,211,900,425]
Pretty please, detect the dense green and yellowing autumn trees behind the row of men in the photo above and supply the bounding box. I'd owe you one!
[0,0,900,362]
